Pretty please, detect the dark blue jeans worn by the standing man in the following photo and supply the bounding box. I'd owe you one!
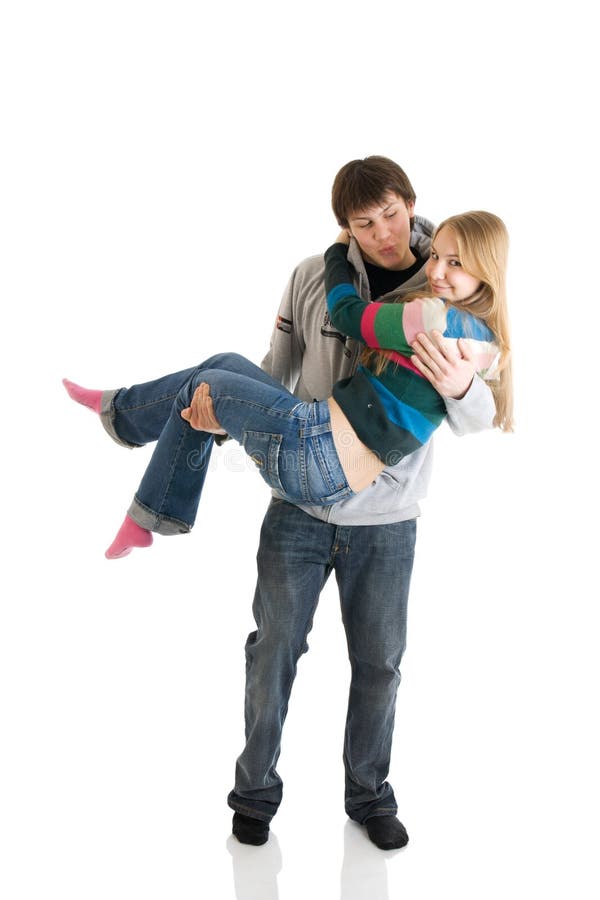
[228,500,416,823]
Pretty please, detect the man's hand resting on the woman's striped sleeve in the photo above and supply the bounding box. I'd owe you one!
[411,331,475,400]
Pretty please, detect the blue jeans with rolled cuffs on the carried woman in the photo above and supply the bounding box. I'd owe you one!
[102,353,352,534]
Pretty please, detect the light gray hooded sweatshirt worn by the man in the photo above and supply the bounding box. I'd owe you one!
[262,216,495,525]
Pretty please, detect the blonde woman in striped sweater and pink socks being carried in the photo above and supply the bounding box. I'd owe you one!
[64,211,512,559]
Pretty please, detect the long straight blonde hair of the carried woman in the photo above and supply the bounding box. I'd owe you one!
[361,210,513,431]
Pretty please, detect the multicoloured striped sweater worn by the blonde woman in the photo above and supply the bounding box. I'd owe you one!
[325,244,498,466]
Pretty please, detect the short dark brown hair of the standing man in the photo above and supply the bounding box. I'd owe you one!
[331,156,417,228]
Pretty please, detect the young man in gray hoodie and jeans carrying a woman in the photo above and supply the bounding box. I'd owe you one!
[198,156,494,849]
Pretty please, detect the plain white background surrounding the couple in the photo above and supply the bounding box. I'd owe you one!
[0,0,600,900]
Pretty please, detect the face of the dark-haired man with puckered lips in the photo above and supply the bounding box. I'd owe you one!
[348,191,415,271]
